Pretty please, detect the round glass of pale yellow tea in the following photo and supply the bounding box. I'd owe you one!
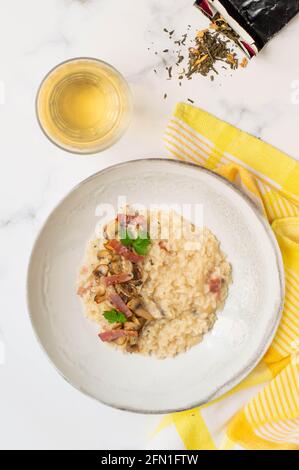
[36,58,132,154]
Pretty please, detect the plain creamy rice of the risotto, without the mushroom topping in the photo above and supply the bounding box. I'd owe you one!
[79,212,231,358]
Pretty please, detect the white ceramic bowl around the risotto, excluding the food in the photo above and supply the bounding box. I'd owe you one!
[28,159,284,413]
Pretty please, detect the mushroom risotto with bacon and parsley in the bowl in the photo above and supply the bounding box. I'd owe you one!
[77,207,231,358]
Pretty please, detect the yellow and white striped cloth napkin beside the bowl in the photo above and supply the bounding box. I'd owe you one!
[150,103,299,450]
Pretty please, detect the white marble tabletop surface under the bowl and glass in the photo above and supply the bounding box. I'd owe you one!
[0,0,299,449]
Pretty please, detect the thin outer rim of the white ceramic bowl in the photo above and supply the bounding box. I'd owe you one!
[26,158,285,414]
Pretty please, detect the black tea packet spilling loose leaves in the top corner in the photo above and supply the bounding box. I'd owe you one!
[195,0,299,57]
